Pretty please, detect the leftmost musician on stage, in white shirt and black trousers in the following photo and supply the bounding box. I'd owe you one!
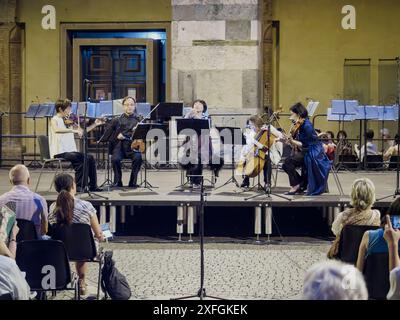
[49,99,104,192]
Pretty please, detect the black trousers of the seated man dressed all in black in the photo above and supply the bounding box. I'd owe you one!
[111,142,142,187]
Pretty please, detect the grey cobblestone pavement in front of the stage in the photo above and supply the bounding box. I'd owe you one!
[52,241,329,300]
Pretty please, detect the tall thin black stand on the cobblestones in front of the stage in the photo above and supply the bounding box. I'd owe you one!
[171,175,225,300]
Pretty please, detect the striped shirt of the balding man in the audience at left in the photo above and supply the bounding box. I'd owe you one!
[0,185,48,236]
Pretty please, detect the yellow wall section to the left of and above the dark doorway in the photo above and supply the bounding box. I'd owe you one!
[17,0,172,151]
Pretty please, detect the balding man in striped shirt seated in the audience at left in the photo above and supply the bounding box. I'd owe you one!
[0,164,47,237]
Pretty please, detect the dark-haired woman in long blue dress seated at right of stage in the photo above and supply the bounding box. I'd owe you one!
[282,103,331,195]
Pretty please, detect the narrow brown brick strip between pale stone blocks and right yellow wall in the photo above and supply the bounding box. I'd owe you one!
[261,0,273,107]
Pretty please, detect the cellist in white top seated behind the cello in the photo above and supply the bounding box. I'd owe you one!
[239,115,283,188]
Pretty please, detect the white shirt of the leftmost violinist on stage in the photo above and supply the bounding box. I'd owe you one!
[49,115,77,158]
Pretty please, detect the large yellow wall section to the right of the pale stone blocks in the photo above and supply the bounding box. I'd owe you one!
[273,0,400,142]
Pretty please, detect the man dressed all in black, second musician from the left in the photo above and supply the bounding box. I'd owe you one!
[108,96,142,188]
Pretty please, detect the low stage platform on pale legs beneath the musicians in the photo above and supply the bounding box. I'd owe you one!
[0,168,396,239]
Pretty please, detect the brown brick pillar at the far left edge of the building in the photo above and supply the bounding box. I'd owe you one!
[0,0,22,164]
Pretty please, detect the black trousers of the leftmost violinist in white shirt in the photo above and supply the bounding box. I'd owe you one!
[54,152,97,190]
